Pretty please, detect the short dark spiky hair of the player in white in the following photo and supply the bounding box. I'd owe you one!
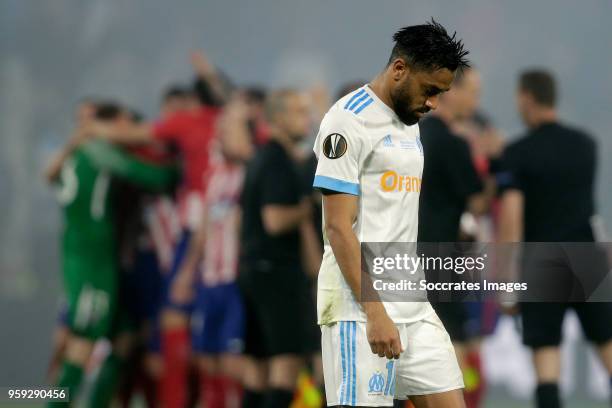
[388,18,470,71]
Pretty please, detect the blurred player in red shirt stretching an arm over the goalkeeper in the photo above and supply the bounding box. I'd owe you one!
[83,53,227,408]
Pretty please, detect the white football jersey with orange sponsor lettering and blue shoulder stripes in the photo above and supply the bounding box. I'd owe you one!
[314,85,433,325]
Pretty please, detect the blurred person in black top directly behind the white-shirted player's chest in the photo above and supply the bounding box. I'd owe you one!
[418,68,491,408]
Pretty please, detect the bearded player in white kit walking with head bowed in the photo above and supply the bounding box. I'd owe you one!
[314,20,468,408]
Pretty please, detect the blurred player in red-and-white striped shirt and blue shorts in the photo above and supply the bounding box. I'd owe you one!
[167,93,253,408]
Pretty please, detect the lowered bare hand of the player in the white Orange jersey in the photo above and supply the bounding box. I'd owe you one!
[366,304,404,359]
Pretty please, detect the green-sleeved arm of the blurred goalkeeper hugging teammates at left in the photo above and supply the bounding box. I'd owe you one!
[83,140,179,191]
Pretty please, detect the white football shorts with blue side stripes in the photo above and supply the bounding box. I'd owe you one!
[321,313,464,407]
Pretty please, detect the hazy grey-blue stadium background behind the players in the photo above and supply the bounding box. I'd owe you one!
[0,0,612,407]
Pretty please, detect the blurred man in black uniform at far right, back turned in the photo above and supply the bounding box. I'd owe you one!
[497,70,612,408]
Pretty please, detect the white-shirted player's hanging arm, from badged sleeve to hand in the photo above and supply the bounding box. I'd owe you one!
[313,111,401,358]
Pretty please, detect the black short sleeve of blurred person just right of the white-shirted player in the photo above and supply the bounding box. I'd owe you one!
[444,137,482,198]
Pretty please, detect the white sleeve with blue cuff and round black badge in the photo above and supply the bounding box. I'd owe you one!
[313,111,371,195]
